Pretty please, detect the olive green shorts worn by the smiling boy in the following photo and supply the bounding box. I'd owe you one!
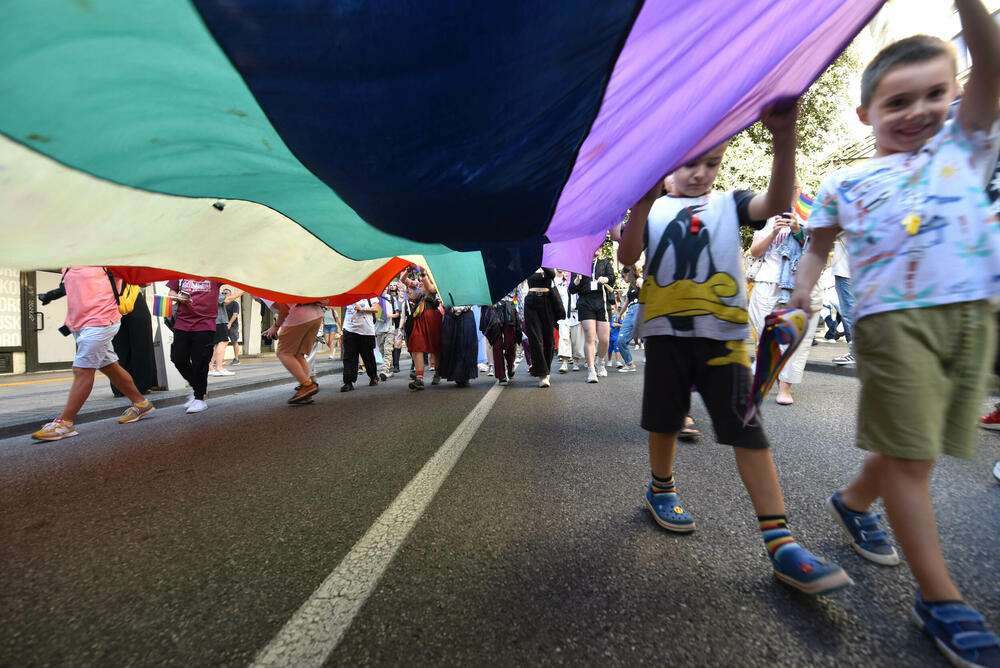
[854,301,997,461]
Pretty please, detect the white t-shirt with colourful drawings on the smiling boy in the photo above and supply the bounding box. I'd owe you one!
[809,116,1000,320]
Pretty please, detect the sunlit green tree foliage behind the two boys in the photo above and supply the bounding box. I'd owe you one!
[715,47,860,248]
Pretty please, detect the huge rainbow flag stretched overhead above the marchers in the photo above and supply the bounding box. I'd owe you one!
[0,0,882,304]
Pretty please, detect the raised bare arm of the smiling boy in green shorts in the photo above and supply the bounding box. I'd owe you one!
[955,0,1000,134]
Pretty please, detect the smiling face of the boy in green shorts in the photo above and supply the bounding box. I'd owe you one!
[858,56,957,157]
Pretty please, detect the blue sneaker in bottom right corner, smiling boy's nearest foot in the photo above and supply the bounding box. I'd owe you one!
[913,591,1000,667]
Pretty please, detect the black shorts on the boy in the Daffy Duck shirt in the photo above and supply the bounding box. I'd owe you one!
[642,335,768,450]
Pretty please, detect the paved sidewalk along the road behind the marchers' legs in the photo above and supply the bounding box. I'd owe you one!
[0,342,854,438]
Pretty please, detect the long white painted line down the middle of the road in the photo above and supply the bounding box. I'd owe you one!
[250,384,503,667]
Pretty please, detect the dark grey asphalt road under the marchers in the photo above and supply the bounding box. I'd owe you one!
[0,365,1000,666]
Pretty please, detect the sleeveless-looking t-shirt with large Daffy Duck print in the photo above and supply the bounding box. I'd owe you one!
[637,190,766,341]
